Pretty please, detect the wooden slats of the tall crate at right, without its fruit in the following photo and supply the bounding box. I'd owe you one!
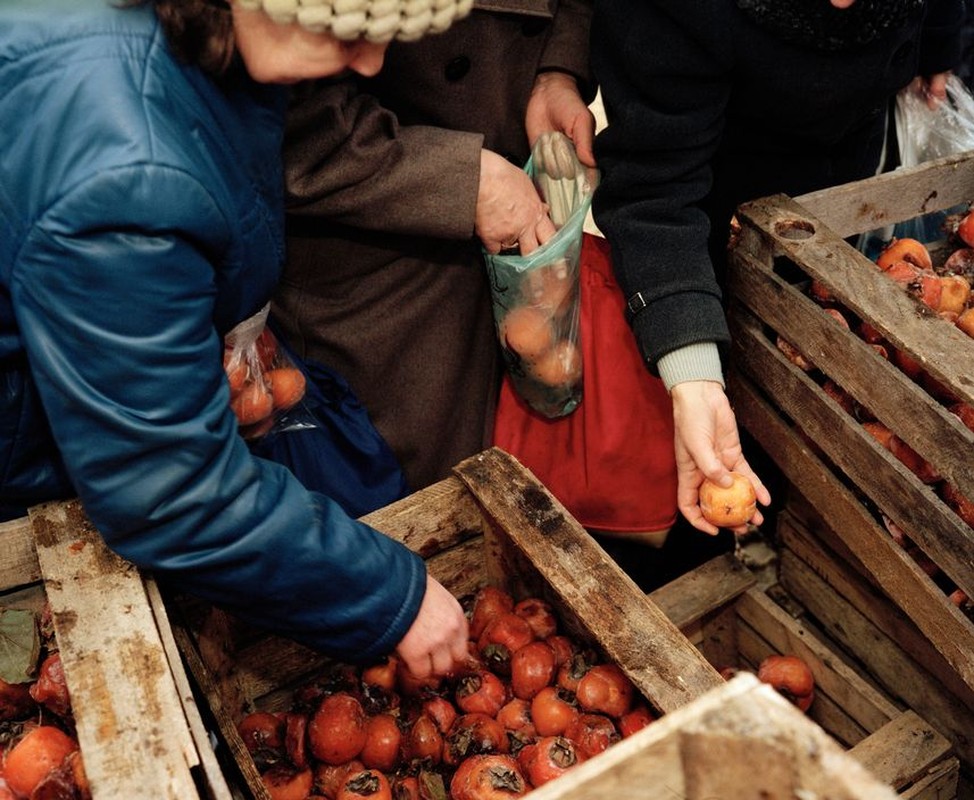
[729,154,974,780]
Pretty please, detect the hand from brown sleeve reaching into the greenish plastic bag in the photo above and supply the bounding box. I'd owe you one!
[474,150,555,255]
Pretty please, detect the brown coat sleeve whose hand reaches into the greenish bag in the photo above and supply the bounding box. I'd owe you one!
[284,79,484,239]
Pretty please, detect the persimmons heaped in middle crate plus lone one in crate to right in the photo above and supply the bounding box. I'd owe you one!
[238,586,814,800]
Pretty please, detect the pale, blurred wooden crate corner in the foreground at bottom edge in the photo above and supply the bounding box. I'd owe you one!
[531,673,897,800]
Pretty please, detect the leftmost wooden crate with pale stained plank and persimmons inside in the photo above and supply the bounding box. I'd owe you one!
[0,501,231,800]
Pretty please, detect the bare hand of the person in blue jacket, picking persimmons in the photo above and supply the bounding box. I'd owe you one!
[396,575,469,678]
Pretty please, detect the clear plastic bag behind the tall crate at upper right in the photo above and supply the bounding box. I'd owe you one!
[858,75,974,260]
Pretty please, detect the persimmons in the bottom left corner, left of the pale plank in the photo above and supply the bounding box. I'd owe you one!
[0,612,91,800]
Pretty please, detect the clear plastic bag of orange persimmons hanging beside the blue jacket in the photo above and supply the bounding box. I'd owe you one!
[223,305,307,439]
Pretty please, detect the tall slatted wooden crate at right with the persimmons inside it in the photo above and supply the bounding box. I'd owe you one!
[729,154,974,788]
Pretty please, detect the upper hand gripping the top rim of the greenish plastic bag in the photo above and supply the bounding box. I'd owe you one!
[524,72,595,167]
